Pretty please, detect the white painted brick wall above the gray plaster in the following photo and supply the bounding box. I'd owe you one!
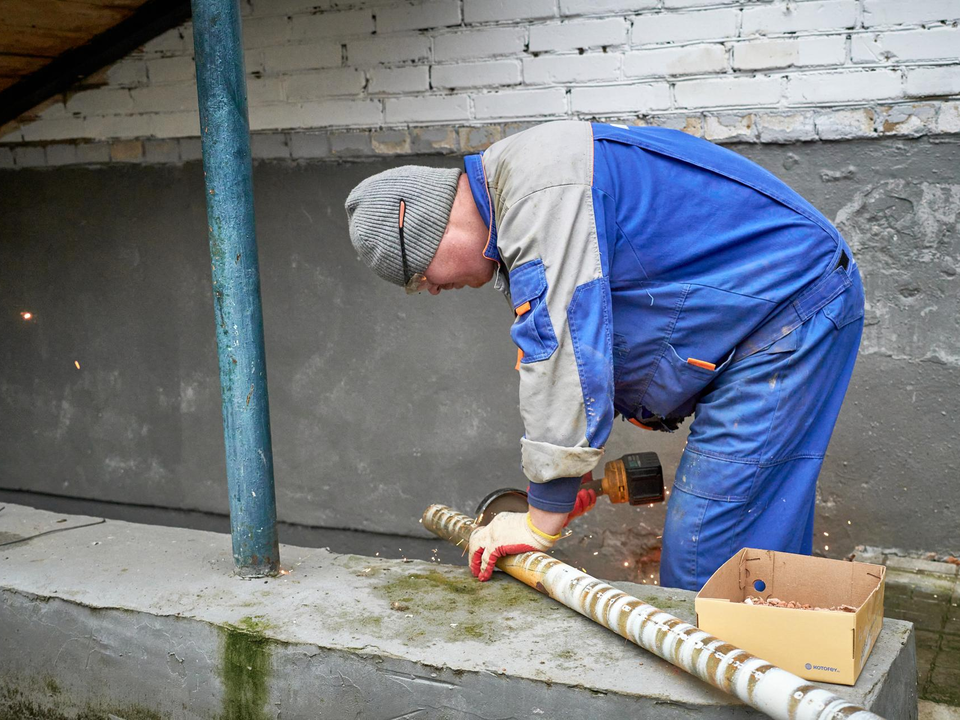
[0,0,960,148]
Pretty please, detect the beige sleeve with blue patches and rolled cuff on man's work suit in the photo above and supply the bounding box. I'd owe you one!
[484,122,613,482]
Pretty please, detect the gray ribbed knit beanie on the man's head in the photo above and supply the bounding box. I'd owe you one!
[346,165,461,286]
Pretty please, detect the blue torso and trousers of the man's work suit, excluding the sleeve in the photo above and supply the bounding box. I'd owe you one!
[594,125,863,590]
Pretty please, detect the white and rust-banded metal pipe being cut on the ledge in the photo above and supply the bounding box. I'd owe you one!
[422,505,882,720]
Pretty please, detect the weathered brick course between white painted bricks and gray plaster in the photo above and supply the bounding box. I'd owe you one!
[0,103,960,169]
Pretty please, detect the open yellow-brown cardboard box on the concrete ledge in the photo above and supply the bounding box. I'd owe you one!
[696,548,886,685]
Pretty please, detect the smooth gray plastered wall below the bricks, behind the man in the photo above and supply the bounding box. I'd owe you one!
[0,138,960,572]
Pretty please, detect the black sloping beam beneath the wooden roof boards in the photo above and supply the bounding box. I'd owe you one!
[0,0,190,125]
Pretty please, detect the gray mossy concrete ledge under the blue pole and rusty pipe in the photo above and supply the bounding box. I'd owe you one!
[0,505,917,720]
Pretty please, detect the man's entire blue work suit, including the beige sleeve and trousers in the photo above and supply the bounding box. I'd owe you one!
[466,123,863,589]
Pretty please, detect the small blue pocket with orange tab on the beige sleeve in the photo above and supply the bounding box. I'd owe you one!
[510,260,558,364]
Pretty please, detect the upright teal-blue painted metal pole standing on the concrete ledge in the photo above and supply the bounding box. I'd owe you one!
[192,0,280,577]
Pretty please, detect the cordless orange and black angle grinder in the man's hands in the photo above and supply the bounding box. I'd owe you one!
[477,452,664,525]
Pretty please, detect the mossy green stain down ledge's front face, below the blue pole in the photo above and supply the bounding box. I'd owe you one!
[220,616,272,720]
